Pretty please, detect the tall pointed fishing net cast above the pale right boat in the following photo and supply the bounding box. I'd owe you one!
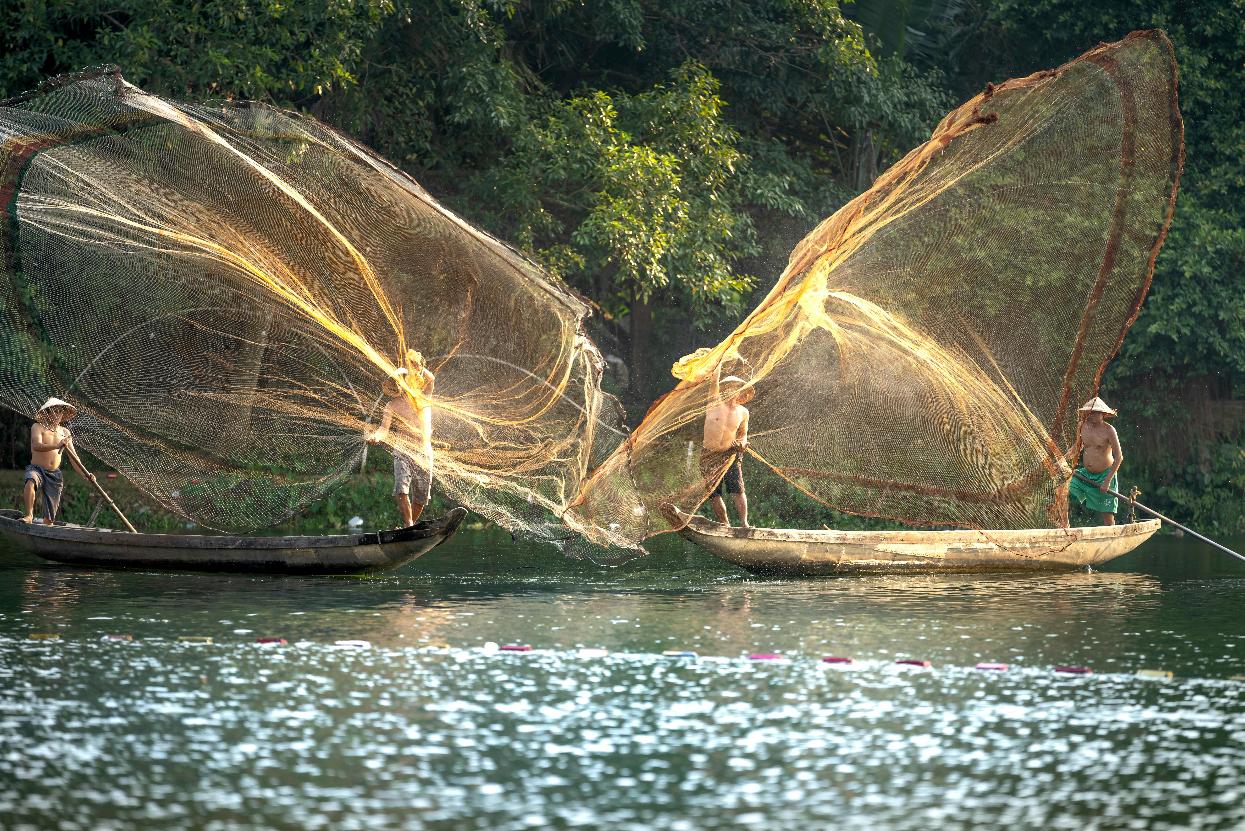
[568,31,1183,544]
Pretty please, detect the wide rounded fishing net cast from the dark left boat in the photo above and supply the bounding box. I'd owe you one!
[0,70,619,538]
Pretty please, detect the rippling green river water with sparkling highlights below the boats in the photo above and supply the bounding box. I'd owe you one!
[0,532,1245,831]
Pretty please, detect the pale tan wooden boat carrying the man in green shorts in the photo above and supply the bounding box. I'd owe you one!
[680,513,1159,574]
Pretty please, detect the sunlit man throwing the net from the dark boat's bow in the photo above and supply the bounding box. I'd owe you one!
[367,350,436,528]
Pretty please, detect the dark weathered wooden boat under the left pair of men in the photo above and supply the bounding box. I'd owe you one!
[0,507,467,574]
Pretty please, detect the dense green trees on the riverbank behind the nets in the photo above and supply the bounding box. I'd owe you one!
[0,0,1245,531]
